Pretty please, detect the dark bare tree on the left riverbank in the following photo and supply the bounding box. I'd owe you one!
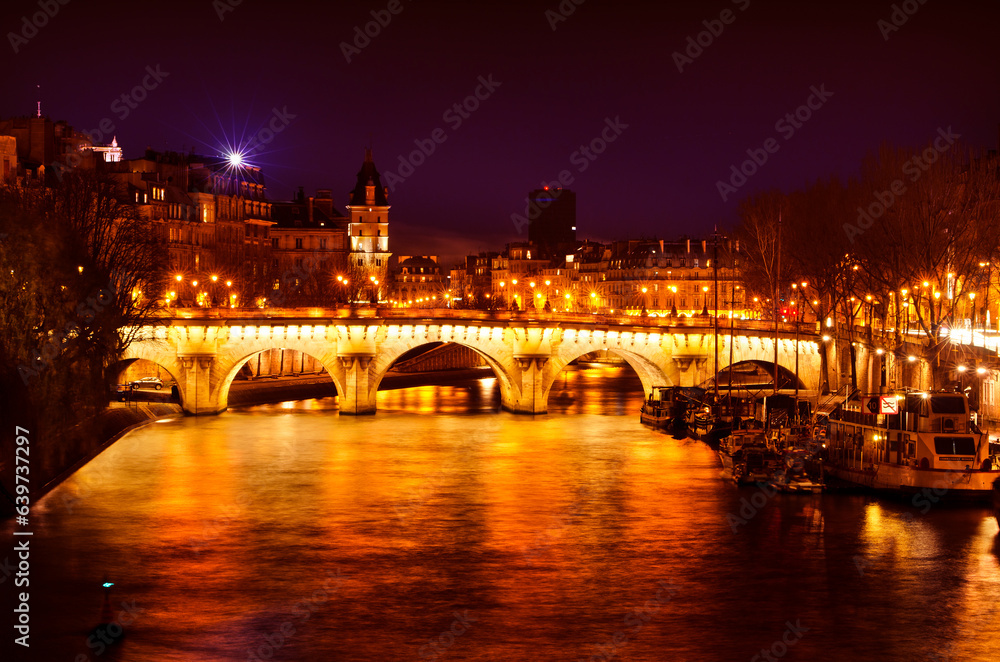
[0,171,165,444]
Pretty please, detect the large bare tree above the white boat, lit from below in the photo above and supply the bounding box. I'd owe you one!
[853,144,1000,360]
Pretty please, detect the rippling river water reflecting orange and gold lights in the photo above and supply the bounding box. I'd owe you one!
[0,367,1000,662]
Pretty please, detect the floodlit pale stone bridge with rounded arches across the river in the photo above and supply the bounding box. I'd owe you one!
[123,308,821,414]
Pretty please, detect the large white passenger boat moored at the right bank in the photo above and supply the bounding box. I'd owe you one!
[827,391,1000,505]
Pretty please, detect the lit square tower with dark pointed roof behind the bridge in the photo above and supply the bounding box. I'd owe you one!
[347,148,392,303]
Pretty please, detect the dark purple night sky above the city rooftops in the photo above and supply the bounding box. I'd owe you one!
[0,0,1000,260]
